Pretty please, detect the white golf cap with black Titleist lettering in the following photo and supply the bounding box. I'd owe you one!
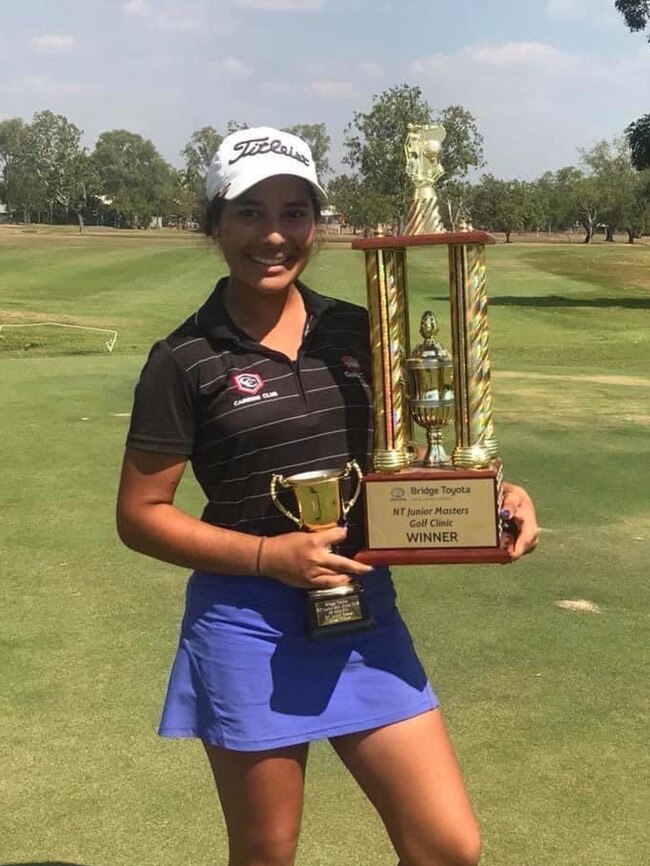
[205,126,327,203]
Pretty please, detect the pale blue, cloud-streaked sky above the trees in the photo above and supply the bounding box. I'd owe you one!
[0,0,650,178]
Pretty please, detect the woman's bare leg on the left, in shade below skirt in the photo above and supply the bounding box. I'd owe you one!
[203,743,309,866]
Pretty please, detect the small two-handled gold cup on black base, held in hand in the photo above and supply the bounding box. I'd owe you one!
[271,460,373,638]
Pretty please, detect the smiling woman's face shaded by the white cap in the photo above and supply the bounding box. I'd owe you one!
[214,175,316,295]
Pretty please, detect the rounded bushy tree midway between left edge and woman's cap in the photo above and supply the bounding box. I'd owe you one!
[92,129,178,228]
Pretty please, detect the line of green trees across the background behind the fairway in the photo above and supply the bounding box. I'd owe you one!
[0,84,650,242]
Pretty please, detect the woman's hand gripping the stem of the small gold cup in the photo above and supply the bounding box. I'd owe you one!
[260,526,372,589]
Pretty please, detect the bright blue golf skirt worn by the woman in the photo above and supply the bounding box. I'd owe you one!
[159,568,438,751]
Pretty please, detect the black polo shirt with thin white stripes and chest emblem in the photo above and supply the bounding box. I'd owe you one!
[127,280,372,554]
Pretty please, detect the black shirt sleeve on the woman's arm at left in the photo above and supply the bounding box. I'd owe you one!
[126,340,198,457]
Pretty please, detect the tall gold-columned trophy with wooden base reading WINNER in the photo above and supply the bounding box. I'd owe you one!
[352,124,510,565]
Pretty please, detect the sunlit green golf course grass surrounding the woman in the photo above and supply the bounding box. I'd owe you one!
[0,227,650,866]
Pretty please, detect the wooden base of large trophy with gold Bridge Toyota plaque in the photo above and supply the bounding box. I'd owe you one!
[355,461,511,565]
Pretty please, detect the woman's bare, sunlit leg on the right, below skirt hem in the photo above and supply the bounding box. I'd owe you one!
[331,710,480,866]
